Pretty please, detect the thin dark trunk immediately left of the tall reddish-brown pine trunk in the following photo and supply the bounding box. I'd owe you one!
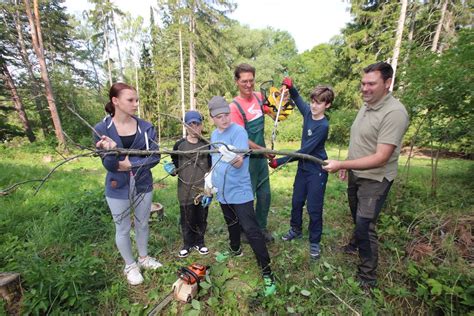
[14,0,50,137]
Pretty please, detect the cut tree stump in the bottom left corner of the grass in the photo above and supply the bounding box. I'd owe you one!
[0,272,22,315]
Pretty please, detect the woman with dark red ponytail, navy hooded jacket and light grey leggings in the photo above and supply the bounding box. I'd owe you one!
[94,82,162,285]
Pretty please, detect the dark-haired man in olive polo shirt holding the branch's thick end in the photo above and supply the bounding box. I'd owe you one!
[323,62,409,289]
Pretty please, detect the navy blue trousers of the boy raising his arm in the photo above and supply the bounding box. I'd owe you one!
[290,168,328,244]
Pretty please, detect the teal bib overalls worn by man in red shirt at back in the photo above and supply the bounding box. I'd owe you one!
[232,93,271,229]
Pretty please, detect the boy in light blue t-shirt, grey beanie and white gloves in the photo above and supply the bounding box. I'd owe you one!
[208,96,276,296]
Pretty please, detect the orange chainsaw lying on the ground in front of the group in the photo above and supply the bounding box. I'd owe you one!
[148,263,209,316]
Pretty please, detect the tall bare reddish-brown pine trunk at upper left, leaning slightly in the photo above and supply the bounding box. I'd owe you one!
[23,0,66,149]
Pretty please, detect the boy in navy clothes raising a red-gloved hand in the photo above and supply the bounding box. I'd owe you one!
[269,77,334,259]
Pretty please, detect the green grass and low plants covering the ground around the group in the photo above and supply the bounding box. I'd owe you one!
[0,143,474,315]
